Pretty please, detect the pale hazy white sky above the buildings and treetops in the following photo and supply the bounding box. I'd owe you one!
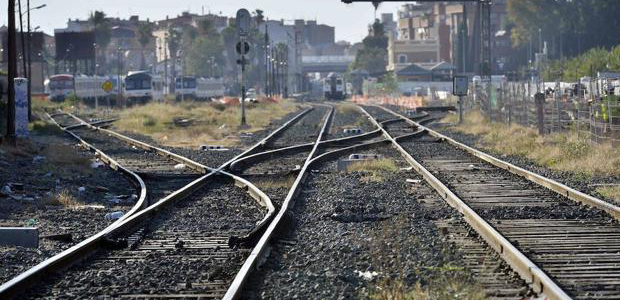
[0,0,401,42]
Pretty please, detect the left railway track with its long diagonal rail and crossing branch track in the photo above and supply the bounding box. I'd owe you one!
[0,109,318,298]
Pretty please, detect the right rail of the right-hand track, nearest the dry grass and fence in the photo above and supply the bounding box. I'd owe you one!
[377,106,620,220]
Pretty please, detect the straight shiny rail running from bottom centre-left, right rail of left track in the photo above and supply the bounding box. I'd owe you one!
[223,106,334,300]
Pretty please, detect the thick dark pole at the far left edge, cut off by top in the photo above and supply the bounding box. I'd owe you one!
[6,0,17,146]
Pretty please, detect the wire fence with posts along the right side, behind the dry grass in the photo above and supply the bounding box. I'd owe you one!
[466,82,620,145]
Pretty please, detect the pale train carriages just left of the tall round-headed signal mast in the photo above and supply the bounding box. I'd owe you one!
[175,76,224,100]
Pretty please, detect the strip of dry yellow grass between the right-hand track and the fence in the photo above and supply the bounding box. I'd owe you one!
[444,111,620,177]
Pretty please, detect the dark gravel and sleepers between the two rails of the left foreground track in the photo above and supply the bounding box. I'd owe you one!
[24,179,265,299]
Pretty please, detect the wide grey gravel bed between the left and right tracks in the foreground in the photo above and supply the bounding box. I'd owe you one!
[242,147,532,299]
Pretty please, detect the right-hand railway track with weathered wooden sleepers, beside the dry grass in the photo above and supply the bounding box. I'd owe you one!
[368,103,620,299]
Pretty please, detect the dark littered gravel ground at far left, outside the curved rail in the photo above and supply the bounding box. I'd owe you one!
[0,127,138,282]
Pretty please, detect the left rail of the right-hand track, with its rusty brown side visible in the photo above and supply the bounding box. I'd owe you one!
[358,106,571,300]
